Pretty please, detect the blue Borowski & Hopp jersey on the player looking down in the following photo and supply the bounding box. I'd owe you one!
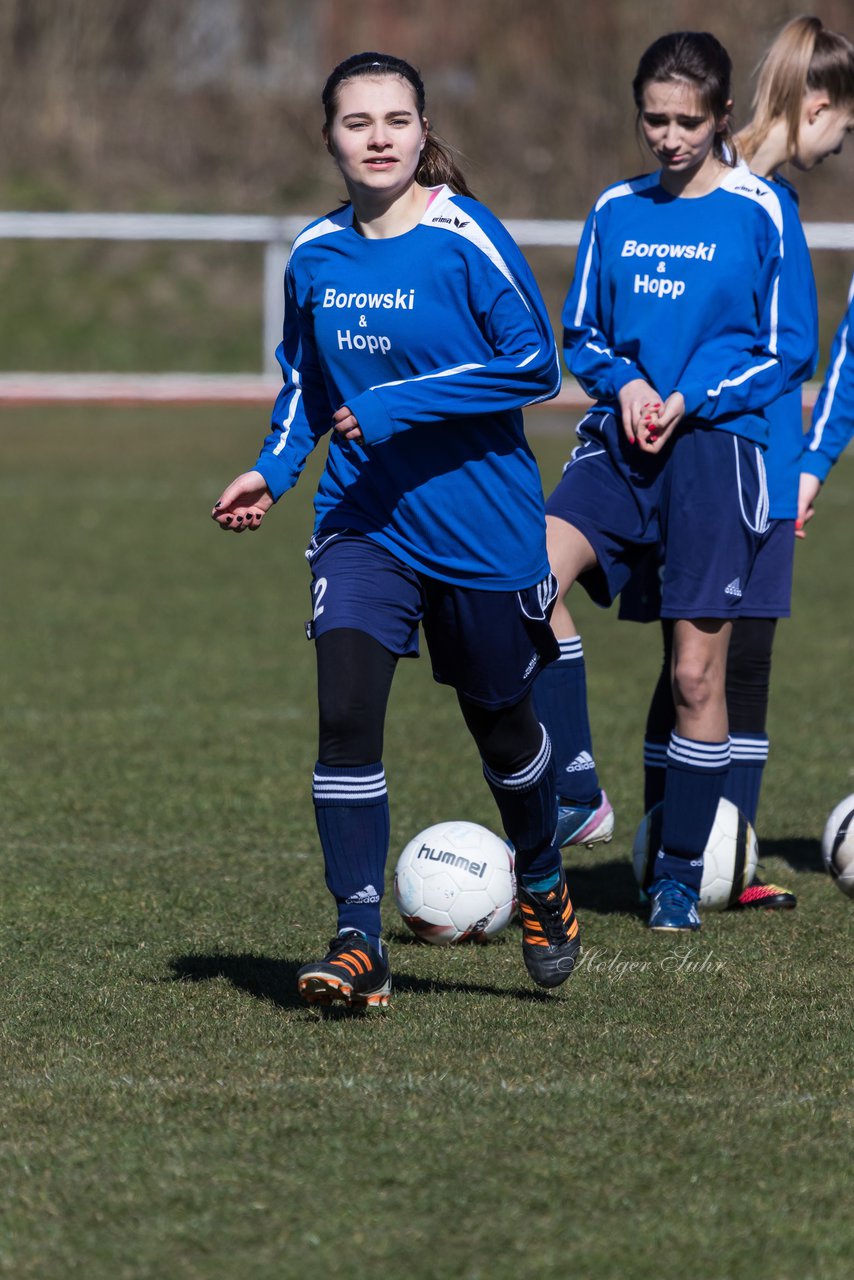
[563,165,804,444]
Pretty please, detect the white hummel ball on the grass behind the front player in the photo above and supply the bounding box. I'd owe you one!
[394,822,516,946]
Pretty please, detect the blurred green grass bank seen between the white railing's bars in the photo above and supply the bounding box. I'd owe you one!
[0,240,850,378]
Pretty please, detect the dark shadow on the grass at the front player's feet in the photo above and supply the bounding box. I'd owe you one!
[170,952,552,1014]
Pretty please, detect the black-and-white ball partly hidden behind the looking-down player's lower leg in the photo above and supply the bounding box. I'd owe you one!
[631,799,758,911]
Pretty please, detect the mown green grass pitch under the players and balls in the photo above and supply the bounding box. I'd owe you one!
[0,408,854,1280]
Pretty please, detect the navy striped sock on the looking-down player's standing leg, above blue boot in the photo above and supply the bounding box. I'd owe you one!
[656,733,730,893]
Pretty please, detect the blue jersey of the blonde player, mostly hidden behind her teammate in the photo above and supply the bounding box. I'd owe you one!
[766,178,818,520]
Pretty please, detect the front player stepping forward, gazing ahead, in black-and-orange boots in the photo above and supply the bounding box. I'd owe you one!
[213,52,579,1006]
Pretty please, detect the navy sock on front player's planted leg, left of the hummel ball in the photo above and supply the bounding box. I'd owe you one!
[311,760,389,950]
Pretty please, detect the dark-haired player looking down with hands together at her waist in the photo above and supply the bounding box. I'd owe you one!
[536,32,791,931]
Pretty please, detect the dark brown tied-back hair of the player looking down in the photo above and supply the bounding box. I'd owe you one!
[631,31,735,165]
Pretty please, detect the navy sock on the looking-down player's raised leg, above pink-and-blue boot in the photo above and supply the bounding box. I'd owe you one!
[534,636,600,806]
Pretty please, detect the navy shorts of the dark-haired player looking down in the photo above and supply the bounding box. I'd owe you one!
[545,411,768,618]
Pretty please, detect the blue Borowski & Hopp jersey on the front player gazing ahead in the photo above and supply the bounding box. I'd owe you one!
[256,187,561,590]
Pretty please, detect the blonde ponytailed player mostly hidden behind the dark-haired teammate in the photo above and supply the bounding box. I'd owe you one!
[620,17,854,909]
